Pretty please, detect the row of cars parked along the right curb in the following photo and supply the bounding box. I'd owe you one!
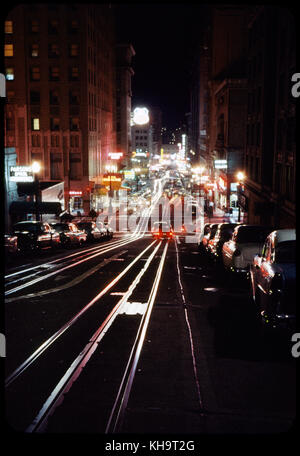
[198,223,296,328]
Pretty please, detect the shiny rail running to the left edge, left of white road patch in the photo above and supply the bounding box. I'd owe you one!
[5,241,157,387]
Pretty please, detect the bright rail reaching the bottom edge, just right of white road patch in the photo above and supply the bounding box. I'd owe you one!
[105,242,169,434]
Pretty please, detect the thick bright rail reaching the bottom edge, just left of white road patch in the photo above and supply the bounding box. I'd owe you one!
[26,242,161,433]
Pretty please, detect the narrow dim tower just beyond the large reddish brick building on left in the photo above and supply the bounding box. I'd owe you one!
[116,44,135,167]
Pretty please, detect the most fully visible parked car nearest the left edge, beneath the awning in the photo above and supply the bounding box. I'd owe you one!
[13,221,60,252]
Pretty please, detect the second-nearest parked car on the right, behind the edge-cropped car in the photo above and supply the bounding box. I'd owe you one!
[222,224,272,276]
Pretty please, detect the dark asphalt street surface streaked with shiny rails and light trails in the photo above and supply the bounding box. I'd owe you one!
[5,231,296,437]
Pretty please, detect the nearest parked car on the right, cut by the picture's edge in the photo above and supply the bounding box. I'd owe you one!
[250,229,296,329]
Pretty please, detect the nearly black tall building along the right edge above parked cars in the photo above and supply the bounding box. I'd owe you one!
[244,6,296,228]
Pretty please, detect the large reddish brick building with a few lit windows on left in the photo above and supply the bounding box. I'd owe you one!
[4,4,116,219]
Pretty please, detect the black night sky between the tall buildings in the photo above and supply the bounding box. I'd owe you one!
[114,3,205,128]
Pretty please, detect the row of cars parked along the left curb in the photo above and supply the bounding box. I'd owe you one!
[5,221,113,253]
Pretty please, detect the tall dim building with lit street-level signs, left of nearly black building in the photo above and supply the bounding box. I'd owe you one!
[206,5,249,207]
